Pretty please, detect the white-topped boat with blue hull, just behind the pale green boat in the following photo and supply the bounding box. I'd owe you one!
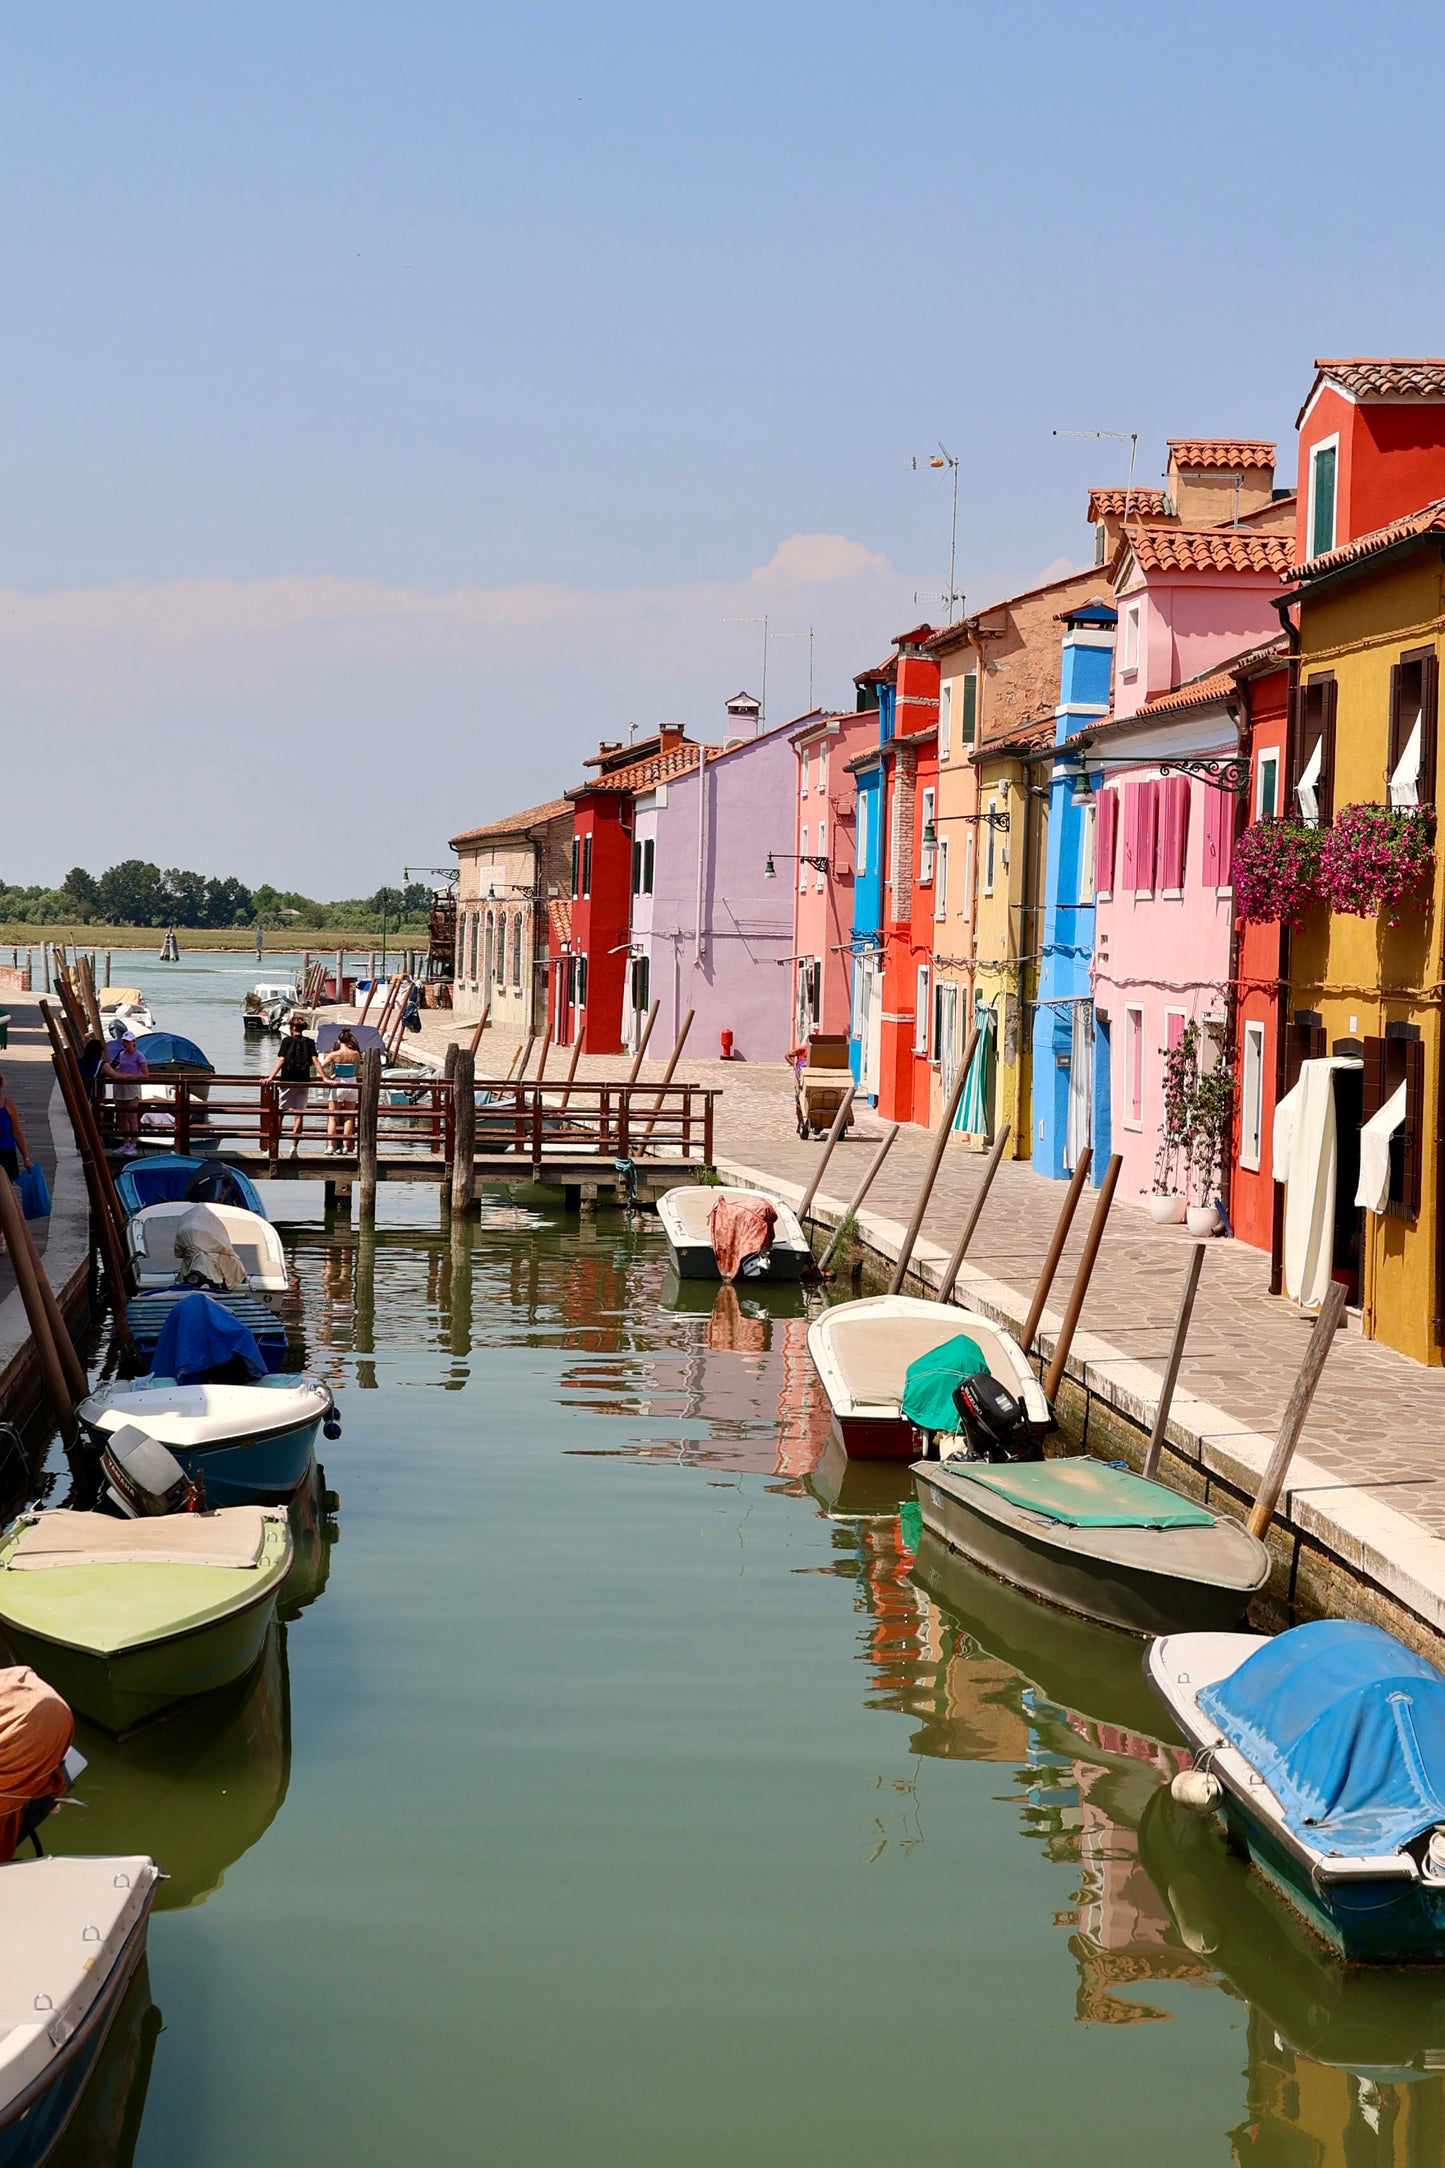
[76,1377,336,1505]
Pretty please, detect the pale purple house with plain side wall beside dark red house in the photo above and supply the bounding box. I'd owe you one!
[624,694,797,1062]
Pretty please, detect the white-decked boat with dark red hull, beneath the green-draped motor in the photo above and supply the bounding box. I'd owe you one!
[808,1294,1051,1461]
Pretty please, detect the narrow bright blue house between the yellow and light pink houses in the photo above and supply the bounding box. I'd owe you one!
[1033,603,1118,1182]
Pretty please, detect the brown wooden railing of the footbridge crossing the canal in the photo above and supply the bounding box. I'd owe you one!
[100,1071,717,1166]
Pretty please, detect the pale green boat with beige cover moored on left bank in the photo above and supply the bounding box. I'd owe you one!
[0,1505,292,1732]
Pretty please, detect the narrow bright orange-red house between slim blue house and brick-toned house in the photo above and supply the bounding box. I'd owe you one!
[877,624,938,1123]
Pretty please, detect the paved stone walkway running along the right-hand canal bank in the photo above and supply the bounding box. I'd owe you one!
[412,1015,1445,1537]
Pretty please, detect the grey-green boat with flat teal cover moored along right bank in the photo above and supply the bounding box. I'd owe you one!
[912,1455,1270,1635]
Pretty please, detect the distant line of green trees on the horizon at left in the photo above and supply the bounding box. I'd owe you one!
[0,859,431,934]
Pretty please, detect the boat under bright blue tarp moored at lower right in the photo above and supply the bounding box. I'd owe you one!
[1144,1619,1445,1964]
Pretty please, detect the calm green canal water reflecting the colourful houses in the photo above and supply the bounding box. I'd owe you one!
[28,958,1445,2168]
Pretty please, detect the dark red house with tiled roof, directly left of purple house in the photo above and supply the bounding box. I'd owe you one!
[548,724,700,1054]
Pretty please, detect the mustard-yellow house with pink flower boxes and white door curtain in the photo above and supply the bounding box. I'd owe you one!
[1274,503,1445,1364]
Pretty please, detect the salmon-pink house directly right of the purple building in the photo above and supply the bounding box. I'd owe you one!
[778,709,877,1038]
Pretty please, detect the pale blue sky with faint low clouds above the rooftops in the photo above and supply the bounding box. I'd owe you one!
[0,0,1445,893]
